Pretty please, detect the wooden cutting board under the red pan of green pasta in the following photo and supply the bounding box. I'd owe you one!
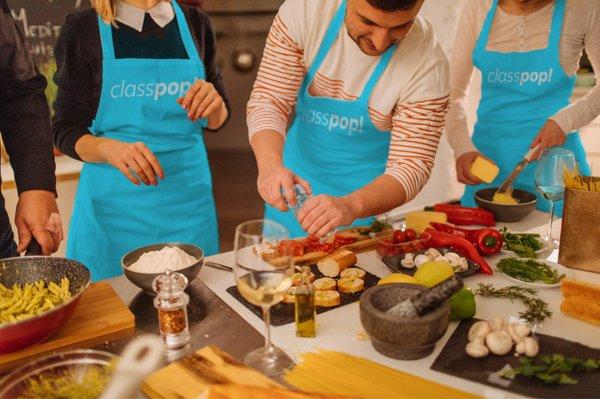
[0,283,135,373]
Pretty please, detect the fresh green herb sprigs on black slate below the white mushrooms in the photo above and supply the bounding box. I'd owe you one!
[502,354,600,385]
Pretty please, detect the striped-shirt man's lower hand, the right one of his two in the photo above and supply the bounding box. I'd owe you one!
[296,195,358,237]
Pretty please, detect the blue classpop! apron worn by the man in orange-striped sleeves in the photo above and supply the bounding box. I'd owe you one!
[265,0,396,237]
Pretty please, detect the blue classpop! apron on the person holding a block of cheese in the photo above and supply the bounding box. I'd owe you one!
[461,0,590,215]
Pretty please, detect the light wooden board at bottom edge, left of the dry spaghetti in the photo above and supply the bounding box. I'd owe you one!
[142,346,282,399]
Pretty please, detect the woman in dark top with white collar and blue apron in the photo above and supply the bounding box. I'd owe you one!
[55,0,227,280]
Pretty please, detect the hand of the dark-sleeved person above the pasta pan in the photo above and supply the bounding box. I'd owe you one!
[15,190,63,255]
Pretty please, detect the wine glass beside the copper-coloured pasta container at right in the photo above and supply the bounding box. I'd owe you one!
[535,148,577,249]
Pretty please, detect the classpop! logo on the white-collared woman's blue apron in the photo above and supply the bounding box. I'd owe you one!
[110,77,198,101]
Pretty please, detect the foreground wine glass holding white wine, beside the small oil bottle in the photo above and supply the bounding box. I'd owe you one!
[233,219,294,376]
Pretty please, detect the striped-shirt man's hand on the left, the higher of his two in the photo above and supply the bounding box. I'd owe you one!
[256,165,312,212]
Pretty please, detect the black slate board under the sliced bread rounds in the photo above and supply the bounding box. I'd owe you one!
[226,265,379,327]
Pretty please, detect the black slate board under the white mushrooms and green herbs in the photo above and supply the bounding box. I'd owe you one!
[431,319,600,399]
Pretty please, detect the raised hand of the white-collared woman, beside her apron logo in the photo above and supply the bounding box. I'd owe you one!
[177,80,227,128]
